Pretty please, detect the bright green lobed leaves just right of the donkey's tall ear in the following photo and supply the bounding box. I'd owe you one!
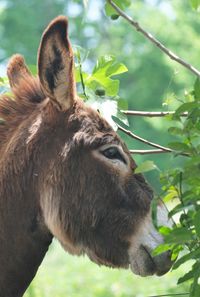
[74,46,128,129]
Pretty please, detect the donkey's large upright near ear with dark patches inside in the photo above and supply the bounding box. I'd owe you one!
[38,16,76,111]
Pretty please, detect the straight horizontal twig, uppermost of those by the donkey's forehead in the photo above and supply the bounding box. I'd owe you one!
[121,110,188,118]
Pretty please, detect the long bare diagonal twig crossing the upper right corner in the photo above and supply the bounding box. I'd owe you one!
[107,0,200,77]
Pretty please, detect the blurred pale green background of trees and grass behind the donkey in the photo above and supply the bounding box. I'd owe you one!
[0,0,200,297]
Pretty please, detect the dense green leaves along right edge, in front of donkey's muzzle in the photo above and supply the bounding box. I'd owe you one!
[151,78,200,297]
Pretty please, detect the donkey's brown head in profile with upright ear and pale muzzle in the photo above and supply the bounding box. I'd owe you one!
[8,16,171,276]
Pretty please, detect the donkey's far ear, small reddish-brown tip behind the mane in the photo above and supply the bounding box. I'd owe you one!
[7,54,32,89]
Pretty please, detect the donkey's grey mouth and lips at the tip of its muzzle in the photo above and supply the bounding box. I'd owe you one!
[130,245,172,276]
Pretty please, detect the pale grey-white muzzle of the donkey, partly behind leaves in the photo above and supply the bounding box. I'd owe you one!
[129,205,173,276]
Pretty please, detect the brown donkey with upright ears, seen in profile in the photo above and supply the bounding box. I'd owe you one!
[0,16,172,297]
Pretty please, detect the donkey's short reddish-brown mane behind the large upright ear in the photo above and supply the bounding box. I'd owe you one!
[0,68,46,151]
